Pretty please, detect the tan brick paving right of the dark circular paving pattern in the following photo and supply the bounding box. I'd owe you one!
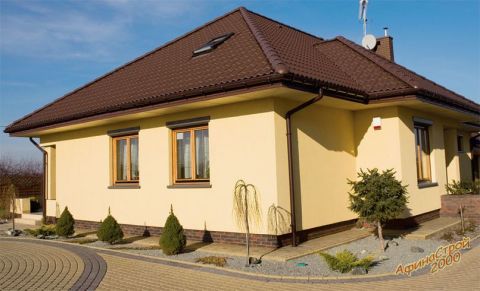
[99,247,480,291]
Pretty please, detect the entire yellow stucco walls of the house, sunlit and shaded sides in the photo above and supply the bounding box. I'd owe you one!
[41,93,471,233]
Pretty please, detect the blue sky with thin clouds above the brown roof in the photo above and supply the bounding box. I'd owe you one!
[0,0,480,159]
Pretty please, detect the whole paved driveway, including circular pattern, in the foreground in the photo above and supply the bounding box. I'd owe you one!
[0,239,480,291]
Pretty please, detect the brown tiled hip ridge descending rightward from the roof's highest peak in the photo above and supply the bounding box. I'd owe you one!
[239,7,289,74]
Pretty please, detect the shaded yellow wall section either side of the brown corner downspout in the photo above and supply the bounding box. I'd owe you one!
[275,100,355,230]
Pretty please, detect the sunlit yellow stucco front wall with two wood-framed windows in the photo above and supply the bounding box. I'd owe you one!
[41,99,277,233]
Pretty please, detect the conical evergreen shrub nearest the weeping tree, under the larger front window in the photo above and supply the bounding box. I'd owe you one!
[160,209,187,256]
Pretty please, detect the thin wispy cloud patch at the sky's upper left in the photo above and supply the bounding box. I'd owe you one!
[0,2,127,58]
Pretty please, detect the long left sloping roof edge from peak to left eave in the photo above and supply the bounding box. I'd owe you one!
[3,7,245,131]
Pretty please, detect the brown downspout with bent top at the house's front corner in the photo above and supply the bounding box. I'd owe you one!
[285,88,323,247]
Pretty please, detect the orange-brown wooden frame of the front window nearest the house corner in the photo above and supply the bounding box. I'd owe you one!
[172,124,210,185]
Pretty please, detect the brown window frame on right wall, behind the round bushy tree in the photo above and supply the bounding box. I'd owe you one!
[414,123,432,183]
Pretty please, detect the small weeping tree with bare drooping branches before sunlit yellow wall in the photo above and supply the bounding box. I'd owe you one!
[233,180,260,266]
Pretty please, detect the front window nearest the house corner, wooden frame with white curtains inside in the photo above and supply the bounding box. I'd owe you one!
[173,126,210,183]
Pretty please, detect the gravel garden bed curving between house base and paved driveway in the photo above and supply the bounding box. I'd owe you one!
[5,223,480,277]
